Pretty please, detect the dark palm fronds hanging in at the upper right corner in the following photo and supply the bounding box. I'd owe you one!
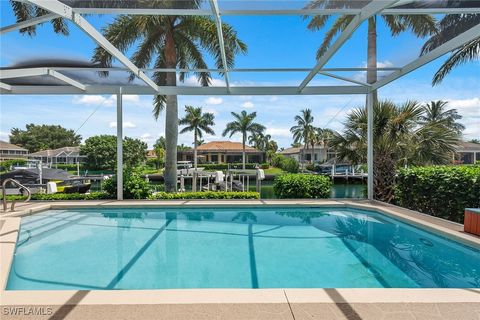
[421,13,480,85]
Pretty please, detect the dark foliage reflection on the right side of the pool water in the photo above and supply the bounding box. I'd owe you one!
[335,217,480,288]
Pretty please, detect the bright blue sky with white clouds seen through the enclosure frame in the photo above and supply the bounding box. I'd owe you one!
[0,0,480,147]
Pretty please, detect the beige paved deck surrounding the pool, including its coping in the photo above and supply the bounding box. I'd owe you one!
[0,200,480,320]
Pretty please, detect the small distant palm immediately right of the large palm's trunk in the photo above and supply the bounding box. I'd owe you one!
[179,106,215,170]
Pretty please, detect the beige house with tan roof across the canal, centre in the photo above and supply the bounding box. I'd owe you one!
[177,141,265,163]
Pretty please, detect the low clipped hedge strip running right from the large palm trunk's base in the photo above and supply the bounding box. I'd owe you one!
[148,191,260,200]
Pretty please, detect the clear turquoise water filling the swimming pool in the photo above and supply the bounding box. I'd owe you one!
[7,207,480,290]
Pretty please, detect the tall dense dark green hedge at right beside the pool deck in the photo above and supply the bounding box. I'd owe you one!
[395,166,480,223]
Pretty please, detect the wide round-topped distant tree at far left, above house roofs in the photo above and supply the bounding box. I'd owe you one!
[10,123,82,152]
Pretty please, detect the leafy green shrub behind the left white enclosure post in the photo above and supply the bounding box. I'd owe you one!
[103,168,151,199]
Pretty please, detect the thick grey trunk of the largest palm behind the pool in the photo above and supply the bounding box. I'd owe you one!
[164,28,178,192]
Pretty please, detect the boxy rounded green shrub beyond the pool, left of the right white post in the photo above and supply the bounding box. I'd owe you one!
[273,174,332,199]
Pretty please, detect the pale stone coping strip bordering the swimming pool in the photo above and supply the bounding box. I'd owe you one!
[0,199,480,306]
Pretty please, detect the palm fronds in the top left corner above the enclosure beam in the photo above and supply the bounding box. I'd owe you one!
[10,0,69,36]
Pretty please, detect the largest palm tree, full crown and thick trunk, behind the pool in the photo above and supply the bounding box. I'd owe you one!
[92,0,247,192]
